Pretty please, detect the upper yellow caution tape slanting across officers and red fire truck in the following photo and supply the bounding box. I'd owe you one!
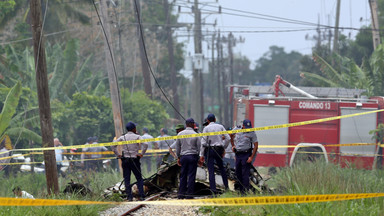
[8,109,384,151]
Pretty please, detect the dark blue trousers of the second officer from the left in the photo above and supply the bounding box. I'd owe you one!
[178,154,199,199]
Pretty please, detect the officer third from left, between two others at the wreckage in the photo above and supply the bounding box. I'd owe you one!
[200,113,230,194]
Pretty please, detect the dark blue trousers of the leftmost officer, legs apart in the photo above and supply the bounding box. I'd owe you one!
[121,158,145,200]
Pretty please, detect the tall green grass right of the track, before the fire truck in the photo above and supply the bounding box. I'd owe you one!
[200,161,384,216]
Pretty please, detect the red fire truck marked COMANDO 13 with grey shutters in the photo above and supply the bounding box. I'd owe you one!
[230,75,384,169]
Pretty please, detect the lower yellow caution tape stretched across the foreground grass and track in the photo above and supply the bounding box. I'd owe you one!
[0,193,384,206]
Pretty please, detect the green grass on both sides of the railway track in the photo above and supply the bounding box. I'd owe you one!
[5,158,384,216]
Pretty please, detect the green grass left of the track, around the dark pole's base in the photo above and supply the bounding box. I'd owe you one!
[0,163,122,216]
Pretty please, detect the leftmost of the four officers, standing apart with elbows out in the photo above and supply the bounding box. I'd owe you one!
[112,122,148,201]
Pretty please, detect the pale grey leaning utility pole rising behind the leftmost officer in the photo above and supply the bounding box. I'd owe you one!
[100,0,124,158]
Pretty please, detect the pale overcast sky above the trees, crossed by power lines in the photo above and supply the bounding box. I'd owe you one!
[177,0,370,67]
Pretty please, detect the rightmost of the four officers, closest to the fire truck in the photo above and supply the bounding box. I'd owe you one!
[231,119,259,194]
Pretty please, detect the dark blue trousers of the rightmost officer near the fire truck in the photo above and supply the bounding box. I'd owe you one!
[236,151,251,193]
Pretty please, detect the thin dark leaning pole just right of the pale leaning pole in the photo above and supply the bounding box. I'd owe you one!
[133,0,152,98]
